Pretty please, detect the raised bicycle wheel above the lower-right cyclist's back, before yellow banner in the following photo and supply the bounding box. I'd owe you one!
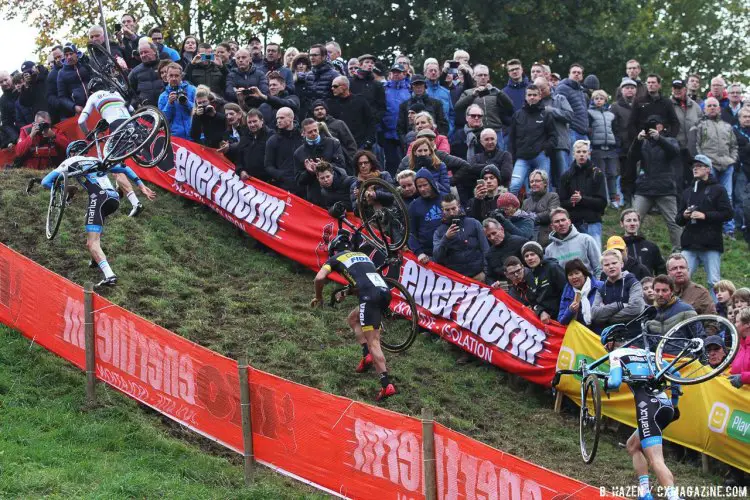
[656,314,739,385]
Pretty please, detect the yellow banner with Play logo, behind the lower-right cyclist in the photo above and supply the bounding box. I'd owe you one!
[557,321,750,472]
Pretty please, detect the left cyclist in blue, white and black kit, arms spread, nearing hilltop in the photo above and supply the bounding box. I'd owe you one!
[42,141,156,287]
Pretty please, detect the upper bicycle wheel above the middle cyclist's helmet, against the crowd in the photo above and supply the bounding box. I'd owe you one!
[357,177,409,252]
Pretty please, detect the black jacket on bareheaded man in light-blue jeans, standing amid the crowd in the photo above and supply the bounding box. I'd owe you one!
[508,102,557,160]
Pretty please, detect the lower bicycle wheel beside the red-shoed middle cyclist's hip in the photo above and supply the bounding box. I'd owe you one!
[380,278,419,352]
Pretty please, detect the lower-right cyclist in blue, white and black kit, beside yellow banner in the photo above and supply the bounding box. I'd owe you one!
[601,325,680,500]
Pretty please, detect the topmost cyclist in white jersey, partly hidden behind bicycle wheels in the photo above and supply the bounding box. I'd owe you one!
[78,77,151,217]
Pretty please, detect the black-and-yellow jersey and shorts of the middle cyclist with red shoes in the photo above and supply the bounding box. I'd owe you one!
[323,250,391,332]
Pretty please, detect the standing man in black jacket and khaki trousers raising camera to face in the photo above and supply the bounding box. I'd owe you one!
[628,115,682,251]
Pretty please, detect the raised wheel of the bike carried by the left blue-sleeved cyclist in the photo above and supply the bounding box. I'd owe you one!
[103,108,163,163]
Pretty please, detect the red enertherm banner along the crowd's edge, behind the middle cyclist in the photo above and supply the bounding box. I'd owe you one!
[132,139,565,385]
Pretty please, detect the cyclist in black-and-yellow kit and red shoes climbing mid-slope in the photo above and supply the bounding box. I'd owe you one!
[311,231,398,401]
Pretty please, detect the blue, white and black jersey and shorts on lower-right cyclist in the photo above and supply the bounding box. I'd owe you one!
[607,347,680,448]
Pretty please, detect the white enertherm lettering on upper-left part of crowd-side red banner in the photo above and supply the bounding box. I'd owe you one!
[174,147,286,236]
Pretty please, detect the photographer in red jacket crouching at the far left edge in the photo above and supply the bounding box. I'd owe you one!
[15,111,70,170]
